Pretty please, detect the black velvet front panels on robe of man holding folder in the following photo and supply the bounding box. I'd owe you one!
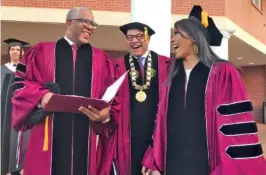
[52,39,92,175]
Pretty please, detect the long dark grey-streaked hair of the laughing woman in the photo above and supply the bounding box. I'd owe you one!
[168,17,227,82]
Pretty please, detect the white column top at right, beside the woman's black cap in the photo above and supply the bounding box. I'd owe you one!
[211,30,234,60]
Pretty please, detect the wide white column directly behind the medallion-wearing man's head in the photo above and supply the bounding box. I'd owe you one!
[131,0,172,56]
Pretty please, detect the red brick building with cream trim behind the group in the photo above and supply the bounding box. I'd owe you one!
[1,0,266,122]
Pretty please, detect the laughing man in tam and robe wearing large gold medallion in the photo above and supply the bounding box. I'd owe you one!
[111,22,170,175]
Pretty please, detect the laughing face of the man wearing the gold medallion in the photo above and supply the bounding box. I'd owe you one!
[126,29,150,56]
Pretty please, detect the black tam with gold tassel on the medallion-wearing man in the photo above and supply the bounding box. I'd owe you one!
[120,22,155,38]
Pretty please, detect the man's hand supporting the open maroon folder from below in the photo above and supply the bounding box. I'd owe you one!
[79,106,110,122]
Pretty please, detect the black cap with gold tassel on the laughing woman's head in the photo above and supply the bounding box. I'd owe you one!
[189,5,223,46]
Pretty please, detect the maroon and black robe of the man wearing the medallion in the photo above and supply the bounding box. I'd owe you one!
[113,51,170,175]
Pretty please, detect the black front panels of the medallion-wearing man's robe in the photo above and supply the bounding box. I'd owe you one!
[124,51,159,175]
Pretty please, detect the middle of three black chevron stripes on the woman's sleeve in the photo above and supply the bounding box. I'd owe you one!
[220,122,258,136]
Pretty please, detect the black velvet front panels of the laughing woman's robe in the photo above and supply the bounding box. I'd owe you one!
[166,62,210,175]
